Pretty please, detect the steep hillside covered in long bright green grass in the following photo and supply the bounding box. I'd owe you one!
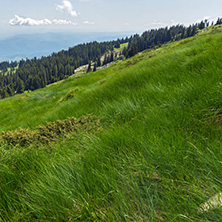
[0,29,222,221]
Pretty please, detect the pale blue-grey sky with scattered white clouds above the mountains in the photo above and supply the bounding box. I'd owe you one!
[0,0,222,37]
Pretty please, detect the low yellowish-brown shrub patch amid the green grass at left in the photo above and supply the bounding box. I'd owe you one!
[1,114,100,146]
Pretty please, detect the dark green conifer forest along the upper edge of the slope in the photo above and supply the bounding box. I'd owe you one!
[0,18,222,98]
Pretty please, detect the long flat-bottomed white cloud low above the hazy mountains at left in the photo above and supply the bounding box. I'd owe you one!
[9,15,77,26]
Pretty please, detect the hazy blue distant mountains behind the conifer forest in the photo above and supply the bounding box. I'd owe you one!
[0,32,130,62]
